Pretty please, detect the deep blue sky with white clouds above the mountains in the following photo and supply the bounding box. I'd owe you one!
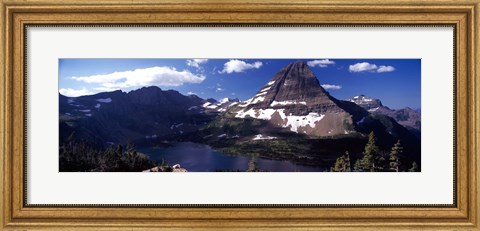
[59,58,421,109]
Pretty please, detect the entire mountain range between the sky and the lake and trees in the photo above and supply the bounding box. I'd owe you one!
[59,62,420,169]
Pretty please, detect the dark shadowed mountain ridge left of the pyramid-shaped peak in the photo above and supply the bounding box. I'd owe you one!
[59,87,238,143]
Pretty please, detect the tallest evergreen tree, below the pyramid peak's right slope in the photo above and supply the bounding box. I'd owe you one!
[354,131,385,172]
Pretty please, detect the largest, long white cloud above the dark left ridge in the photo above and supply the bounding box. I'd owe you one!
[72,66,205,90]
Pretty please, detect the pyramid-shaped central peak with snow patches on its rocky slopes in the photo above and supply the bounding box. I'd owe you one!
[221,62,368,136]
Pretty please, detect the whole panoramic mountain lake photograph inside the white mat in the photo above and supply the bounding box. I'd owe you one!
[58,58,421,174]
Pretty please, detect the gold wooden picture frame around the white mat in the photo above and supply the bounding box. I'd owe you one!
[0,0,480,230]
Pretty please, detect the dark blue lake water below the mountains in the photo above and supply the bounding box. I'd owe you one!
[138,142,324,172]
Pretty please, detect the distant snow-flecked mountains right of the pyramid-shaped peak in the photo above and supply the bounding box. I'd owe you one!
[347,95,421,132]
